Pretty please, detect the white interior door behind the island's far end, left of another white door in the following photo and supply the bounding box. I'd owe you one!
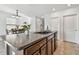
[50,17,60,39]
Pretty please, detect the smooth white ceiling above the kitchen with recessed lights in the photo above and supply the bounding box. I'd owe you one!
[5,4,79,16]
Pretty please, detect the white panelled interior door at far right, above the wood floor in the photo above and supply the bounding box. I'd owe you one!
[63,15,76,42]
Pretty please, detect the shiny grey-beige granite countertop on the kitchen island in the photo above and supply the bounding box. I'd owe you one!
[4,31,55,50]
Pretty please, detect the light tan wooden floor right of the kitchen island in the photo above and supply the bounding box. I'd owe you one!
[54,41,79,55]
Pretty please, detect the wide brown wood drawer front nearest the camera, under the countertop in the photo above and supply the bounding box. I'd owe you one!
[25,39,46,55]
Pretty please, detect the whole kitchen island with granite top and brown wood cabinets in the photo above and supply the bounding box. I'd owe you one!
[4,31,57,55]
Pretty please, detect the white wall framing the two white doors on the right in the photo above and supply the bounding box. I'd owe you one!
[45,8,79,43]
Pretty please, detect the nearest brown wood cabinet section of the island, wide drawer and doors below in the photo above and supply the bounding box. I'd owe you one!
[24,39,46,55]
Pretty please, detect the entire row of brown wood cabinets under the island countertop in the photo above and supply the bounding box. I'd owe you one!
[24,34,57,55]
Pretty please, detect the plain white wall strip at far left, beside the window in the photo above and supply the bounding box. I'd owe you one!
[0,11,8,35]
